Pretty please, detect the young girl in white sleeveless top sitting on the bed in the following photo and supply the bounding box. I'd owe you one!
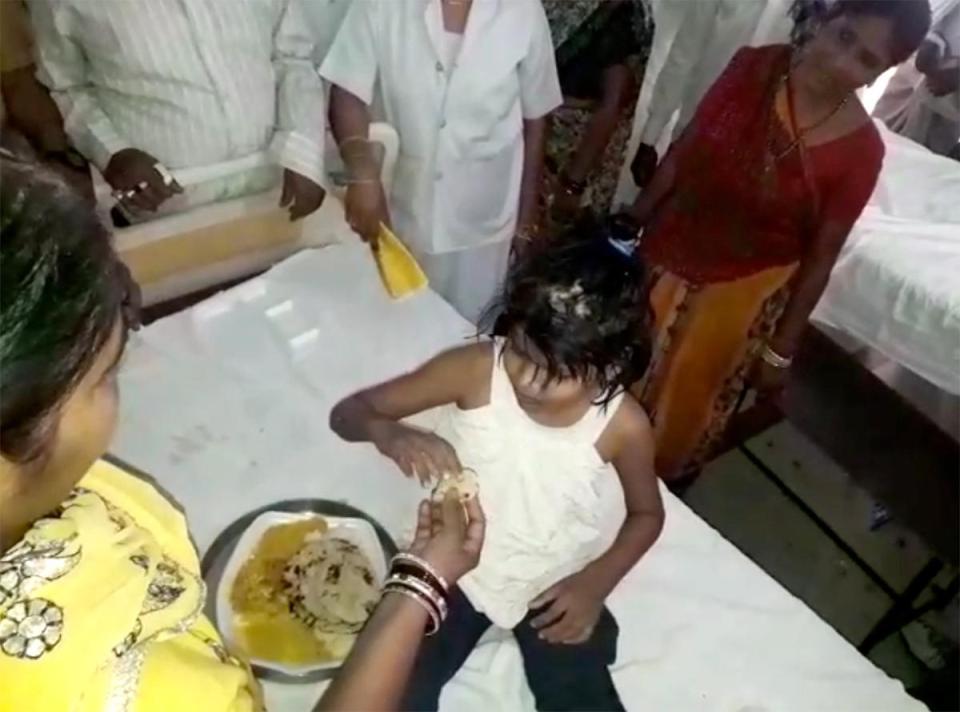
[331,228,663,710]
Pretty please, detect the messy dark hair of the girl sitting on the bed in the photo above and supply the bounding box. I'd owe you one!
[481,219,651,405]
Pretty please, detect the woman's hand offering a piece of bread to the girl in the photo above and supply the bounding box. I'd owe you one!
[410,492,486,585]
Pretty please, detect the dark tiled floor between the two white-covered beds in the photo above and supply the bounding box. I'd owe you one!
[685,332,960,710]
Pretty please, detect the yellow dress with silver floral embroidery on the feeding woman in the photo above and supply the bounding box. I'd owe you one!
[0,462,262,712]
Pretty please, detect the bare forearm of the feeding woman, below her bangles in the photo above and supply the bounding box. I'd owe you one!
[314,593,427,712]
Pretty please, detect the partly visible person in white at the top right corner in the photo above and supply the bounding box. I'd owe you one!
[874,0,960,158]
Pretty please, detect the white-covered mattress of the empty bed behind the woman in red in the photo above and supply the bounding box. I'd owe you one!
[813,125,960,394]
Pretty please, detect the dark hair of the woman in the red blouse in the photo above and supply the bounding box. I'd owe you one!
[790,0,930,64]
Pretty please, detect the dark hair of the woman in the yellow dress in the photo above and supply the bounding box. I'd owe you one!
[0,154,127,462]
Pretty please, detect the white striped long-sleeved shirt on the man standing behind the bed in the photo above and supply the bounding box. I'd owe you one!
[30,0,325,183]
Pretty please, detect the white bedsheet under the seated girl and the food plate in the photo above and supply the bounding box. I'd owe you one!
[114,244,924,712]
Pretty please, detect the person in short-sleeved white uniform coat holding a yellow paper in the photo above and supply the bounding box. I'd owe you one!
[320,0,563,321]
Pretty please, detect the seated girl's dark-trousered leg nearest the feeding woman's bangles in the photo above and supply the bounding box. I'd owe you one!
[400,588,490,712]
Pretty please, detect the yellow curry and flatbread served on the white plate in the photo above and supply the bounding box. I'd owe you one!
[230,517,379,665]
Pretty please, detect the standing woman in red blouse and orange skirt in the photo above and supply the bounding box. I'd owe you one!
[630,0,930,481]
